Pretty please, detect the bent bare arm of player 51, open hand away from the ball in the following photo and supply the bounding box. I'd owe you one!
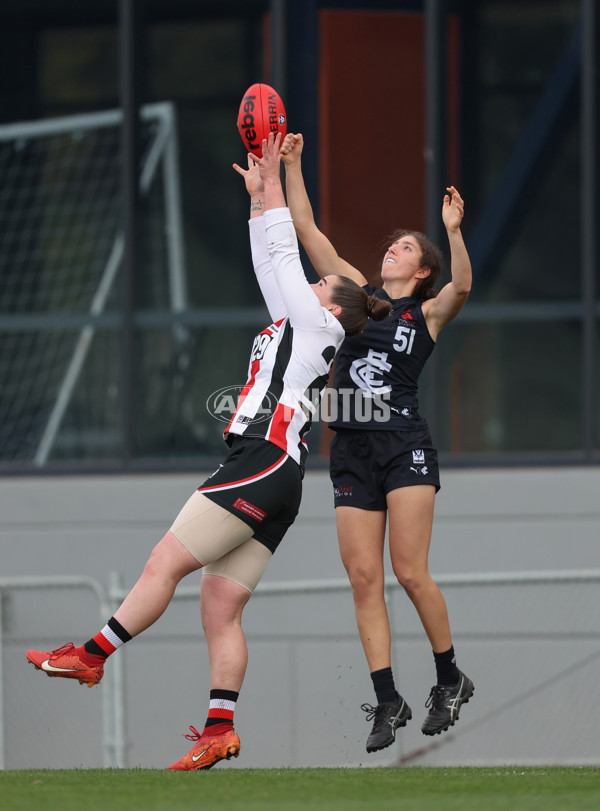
[423,186,472,339]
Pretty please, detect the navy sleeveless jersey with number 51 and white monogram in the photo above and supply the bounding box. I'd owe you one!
[329,285,435,431]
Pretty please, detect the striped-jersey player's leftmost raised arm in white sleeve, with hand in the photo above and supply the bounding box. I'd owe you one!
[233,154,287,323]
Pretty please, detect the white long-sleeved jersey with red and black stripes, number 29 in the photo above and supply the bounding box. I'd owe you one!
[224,208,344,466]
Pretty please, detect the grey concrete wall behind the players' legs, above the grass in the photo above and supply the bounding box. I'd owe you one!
[0,468,600,768]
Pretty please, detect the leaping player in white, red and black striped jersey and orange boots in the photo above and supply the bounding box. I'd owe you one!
[27,135,390,771]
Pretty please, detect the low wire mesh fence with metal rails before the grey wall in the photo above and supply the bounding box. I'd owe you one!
[0,570,600,769]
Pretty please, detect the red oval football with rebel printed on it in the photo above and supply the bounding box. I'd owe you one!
[237,83,287,158]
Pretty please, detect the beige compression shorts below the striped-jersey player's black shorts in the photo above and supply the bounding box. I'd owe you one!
[171,491,272,592]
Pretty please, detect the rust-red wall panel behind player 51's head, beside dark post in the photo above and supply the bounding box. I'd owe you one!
[319,11,460,281]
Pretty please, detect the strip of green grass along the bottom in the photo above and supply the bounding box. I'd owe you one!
[0,766,600,811]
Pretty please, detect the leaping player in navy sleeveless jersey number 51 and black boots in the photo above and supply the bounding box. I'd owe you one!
[282,133,474,752]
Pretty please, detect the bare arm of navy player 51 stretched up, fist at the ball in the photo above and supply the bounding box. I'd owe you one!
[281,133,367,285]
